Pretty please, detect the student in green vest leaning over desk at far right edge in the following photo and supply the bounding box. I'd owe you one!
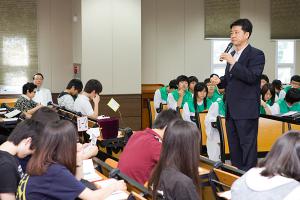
[265,88,300,115]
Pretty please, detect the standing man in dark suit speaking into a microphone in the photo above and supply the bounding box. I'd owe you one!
[211,19,265,171]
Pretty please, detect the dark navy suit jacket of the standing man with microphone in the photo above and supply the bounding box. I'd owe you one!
[219,44,265,119]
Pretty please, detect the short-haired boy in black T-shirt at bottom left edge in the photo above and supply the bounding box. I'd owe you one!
[0,119,42,200]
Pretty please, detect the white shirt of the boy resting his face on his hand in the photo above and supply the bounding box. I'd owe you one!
[74,94,94,116]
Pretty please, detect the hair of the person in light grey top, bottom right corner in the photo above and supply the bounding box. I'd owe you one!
[258,131,300,181]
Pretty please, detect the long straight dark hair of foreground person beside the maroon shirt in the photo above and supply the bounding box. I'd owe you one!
[148,120,200,200]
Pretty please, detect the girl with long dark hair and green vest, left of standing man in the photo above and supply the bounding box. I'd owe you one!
[182,82,211,124]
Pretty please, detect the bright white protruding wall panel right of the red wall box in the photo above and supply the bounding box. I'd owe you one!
[81,0,141,94]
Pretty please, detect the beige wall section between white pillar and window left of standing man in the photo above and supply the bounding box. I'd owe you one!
[142,0,211,83]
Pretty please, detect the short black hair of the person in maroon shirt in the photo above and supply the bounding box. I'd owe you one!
[152,109,180,129]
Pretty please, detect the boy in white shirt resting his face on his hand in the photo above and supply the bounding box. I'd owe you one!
[74,79,102,118]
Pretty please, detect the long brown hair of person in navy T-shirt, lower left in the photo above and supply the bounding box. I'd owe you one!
[27,120,77,175]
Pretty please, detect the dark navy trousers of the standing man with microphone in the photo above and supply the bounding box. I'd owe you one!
[226,116,258,171]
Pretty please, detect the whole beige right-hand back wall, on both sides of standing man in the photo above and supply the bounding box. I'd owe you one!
[142,0,300,84]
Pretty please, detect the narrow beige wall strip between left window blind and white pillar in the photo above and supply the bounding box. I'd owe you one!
[37,0,73,92]
